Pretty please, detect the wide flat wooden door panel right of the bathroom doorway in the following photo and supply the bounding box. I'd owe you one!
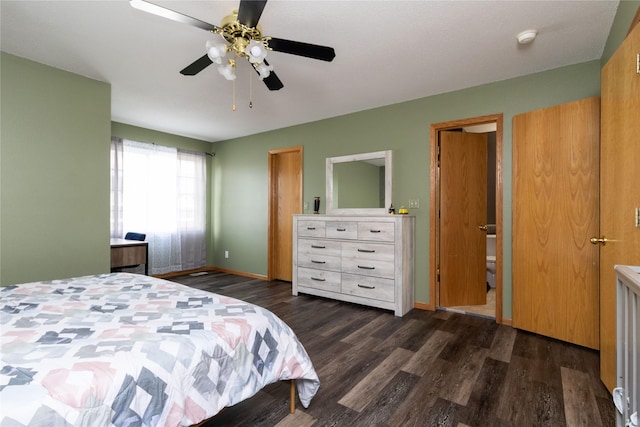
[512,98,600,349]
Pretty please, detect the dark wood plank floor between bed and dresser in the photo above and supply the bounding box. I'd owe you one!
[169,272,615,427]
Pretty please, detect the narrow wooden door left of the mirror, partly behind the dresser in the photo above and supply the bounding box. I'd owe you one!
[268,146,302,282]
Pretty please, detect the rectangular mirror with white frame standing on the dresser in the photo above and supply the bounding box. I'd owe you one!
[326,150,392,215]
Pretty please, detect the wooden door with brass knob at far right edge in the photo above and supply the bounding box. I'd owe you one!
[595,25,640,390]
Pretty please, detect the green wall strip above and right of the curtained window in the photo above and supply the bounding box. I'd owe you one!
[111,122,214,265]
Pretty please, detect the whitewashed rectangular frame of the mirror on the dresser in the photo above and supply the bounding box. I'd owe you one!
[325,150,393,215]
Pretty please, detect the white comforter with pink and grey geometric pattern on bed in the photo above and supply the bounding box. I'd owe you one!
[0,273,320,427]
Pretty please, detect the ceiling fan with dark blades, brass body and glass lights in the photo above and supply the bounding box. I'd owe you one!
[129,0,336,90]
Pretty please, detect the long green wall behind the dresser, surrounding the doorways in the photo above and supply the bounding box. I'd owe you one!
[213,61,600,318]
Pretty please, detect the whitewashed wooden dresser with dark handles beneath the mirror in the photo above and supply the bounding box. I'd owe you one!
[292,215,415,316]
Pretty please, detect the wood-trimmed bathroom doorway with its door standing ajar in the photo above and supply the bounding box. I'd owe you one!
[430,114,502,323]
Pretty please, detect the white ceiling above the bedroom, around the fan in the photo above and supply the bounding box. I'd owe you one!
[0,0,618,141]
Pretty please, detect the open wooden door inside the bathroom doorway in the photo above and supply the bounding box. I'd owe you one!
[439,131,487,307]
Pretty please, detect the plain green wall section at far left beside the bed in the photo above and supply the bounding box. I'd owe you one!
[0,53,111,285]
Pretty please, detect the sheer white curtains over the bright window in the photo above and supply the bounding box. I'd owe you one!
[111,138,206,274]
